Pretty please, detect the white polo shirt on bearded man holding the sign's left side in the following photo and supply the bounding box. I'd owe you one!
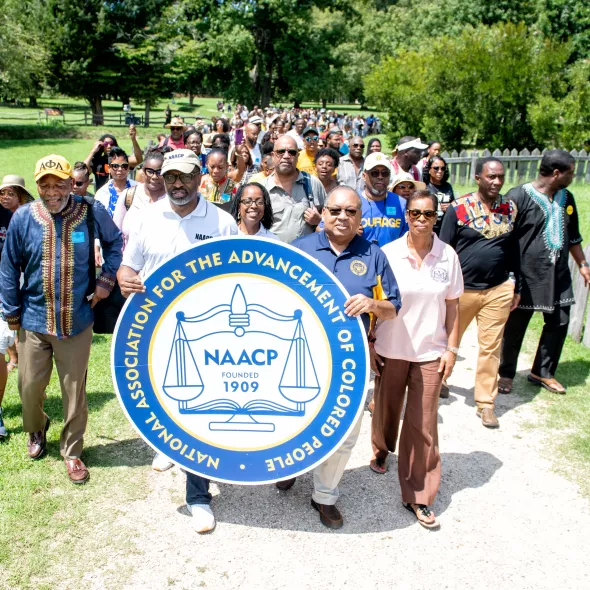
[122,196,238,277]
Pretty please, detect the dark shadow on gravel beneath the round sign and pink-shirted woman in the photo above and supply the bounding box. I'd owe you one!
[191,451,502,534]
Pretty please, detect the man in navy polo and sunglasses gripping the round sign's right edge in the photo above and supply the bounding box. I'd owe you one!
[276,186,401,529]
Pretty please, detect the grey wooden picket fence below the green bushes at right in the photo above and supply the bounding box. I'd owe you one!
[441,148,590,185]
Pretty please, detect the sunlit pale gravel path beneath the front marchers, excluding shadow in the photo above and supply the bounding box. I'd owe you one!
[83,330,590,590]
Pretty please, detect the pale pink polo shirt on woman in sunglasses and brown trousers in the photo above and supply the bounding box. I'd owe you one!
[375,234,463,362]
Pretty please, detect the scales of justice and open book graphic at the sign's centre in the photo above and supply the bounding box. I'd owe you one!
[162,284,320,432]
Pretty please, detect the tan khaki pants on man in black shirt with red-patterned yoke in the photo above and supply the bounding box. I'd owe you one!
[459,281,514,409]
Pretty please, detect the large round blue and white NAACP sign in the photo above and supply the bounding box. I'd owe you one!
[111,237,369,484]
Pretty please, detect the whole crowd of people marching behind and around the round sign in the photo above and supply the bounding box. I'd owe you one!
[0,103,590,532]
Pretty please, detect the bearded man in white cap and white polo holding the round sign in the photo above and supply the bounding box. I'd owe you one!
[117,149,238,533]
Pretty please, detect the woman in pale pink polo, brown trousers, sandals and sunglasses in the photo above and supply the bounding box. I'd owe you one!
[370,190,463,528]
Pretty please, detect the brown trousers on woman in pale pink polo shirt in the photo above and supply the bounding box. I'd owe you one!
[371,358,442,506]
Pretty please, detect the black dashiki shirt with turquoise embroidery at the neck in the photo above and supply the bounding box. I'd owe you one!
[506,183,582,313]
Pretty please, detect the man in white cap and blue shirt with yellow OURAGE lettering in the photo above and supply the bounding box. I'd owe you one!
[361,152,408,246]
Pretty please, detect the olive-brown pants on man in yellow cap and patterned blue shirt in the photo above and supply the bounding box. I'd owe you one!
[18,326,92,459]
